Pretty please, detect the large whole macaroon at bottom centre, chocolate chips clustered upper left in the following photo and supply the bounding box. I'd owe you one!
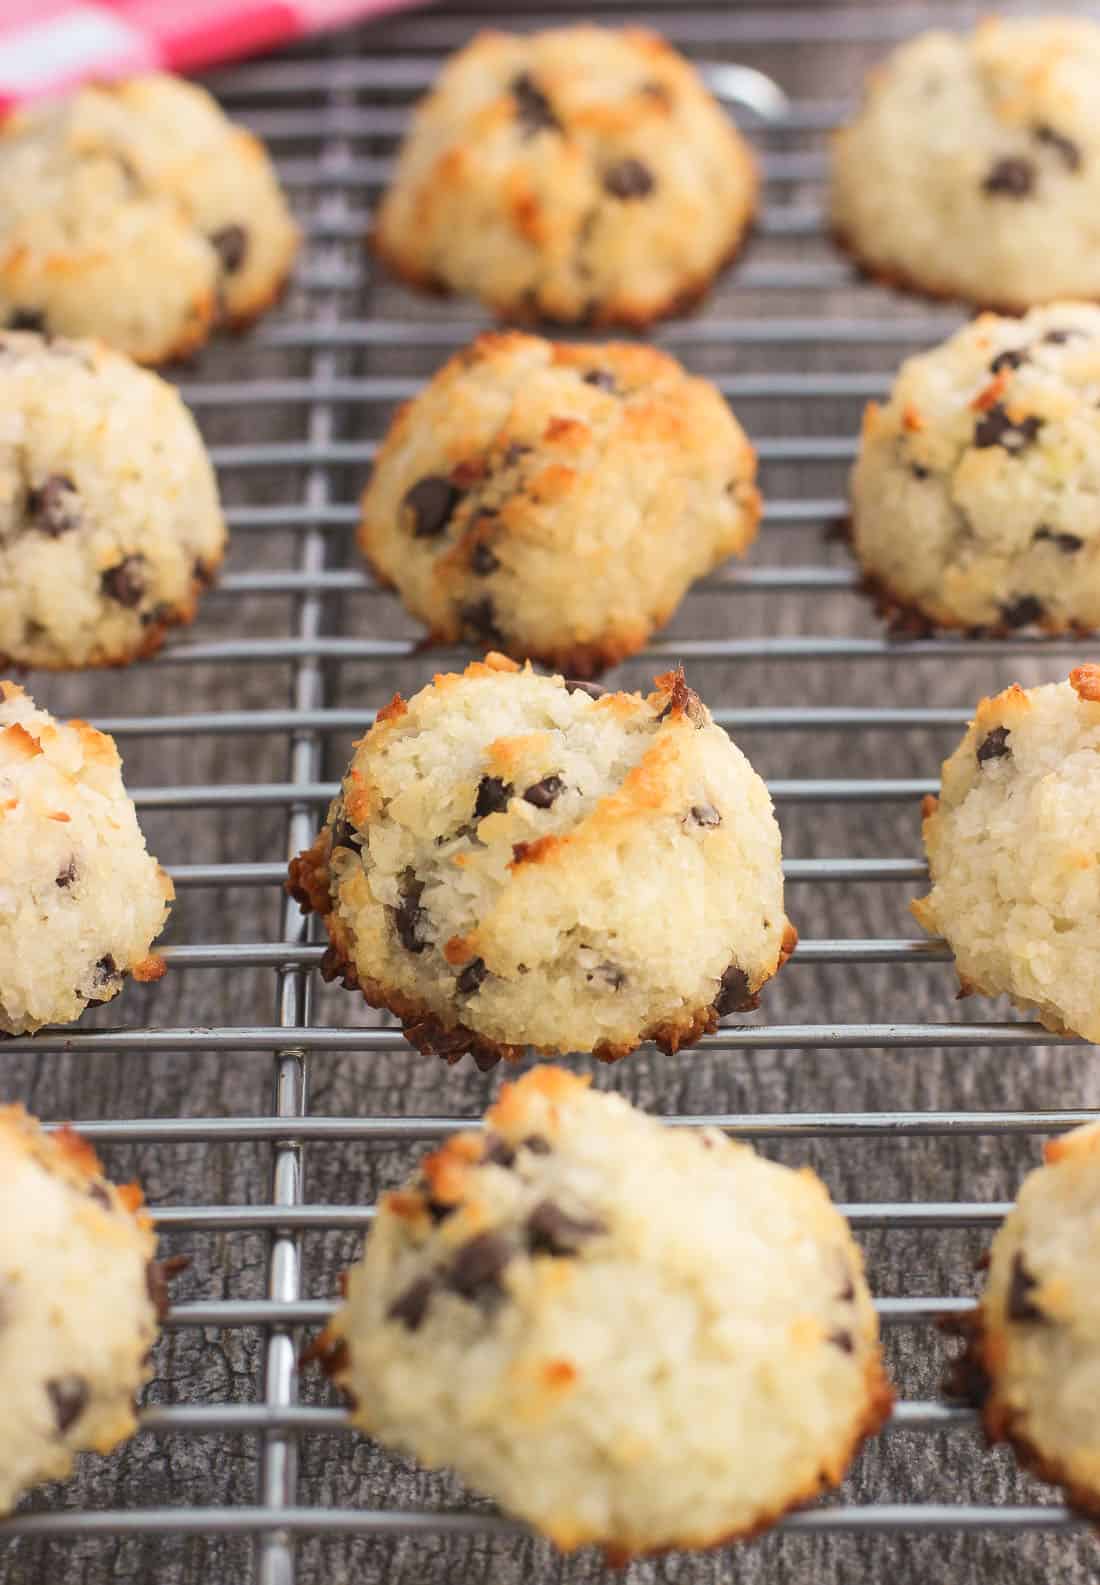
[317,1068,891,1563]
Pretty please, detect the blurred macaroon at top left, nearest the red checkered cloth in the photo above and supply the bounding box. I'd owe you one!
[0,73,298,363]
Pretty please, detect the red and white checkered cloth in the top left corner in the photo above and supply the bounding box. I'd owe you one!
[0,0,411,105]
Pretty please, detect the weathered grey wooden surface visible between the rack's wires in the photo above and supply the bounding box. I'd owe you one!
[0,5,1100,1585]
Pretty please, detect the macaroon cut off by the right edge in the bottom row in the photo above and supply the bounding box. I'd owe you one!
[956,1122,1100,1515]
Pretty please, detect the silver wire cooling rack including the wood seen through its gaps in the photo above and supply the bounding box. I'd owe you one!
[0,5,1100,1585]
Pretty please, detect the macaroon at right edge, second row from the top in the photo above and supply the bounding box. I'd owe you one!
[851,303,1100,634]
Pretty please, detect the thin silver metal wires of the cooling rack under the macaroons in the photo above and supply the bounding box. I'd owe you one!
[0,12,1097,1585]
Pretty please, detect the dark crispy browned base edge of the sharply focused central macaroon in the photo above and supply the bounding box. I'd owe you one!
[287,667,799,1071]
